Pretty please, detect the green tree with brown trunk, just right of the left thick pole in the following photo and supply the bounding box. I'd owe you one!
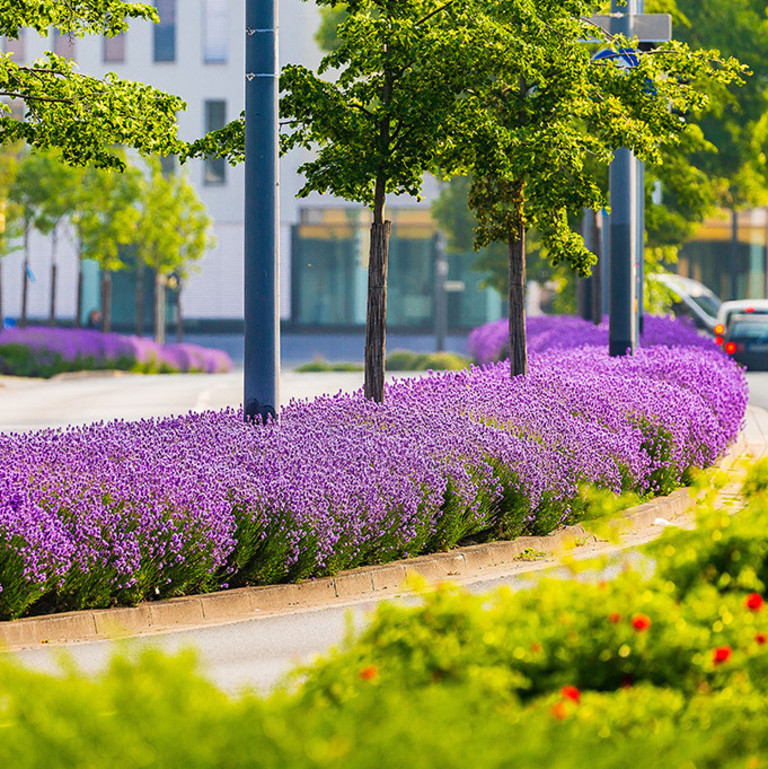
[280,0,512,401]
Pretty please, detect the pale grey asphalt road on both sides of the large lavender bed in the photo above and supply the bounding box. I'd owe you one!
[0,373,768,693]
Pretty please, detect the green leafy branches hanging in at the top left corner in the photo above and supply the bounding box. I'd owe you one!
[0,0,185,168]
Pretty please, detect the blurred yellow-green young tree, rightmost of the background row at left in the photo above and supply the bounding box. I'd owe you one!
[133,159,215,343]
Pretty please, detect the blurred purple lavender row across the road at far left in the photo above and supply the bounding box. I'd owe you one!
[0,327,232,373]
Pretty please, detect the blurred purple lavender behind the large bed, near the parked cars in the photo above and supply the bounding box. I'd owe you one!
[469,315,716,363]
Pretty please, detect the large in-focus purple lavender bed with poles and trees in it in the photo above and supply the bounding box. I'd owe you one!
[0,336,747,617]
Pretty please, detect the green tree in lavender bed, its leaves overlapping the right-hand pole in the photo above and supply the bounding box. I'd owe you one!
[440,0,741,376]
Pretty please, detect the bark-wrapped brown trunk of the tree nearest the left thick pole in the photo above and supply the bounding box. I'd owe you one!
[364,221,392,403]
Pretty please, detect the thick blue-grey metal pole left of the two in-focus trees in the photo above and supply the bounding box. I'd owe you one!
[243,0,280,422]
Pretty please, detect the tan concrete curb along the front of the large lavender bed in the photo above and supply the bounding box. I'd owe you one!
[0,434,747,650]
